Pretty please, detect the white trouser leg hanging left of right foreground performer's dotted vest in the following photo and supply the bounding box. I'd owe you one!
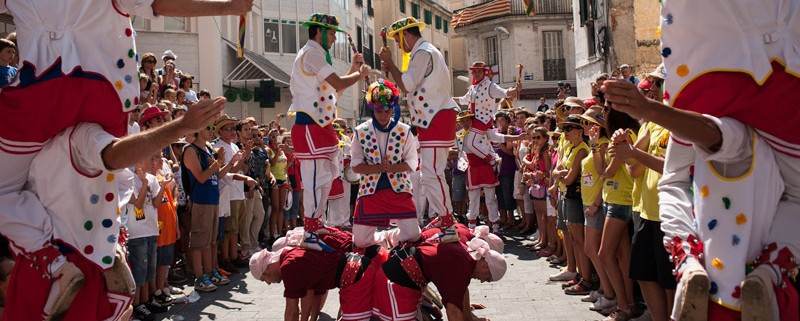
[658,135,697,262]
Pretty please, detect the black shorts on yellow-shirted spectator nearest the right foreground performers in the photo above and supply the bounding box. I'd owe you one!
[629,219,676,290]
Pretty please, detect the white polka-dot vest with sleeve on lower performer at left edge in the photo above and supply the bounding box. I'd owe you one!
[27,123,120,269]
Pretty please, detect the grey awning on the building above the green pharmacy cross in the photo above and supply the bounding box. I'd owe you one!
[222,38,291,86]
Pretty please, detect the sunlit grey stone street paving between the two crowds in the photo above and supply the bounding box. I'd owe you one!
[158,234,616,321]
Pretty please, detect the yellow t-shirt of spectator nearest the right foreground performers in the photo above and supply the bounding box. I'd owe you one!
[641,123,669,222]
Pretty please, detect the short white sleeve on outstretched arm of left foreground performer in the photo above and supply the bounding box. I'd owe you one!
[69,123,117,173]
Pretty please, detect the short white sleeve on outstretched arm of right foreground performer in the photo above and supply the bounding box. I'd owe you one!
[694,115,753,163]
